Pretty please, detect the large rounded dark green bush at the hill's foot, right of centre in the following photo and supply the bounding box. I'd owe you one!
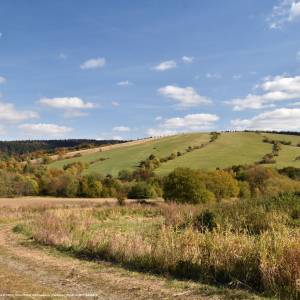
[163,168,215,204]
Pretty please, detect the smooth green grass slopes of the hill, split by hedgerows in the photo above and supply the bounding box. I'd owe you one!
[50,132,300,175]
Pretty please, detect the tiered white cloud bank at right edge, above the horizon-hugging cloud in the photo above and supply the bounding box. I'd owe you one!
[226,76,300,111]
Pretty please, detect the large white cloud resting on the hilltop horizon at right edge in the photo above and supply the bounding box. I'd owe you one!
[231,108,300,130]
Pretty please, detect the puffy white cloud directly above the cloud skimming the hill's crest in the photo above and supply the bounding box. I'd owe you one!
[158,85,211,107]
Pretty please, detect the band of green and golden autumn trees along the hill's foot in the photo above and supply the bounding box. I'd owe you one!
[0,157,300,204]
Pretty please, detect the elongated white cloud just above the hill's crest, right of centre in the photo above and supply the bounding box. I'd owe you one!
[148,114,219,136]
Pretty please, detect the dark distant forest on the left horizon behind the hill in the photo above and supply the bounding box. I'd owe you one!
[0,139,125,156]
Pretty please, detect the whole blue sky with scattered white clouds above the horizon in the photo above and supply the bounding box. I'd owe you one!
[0,0,300,140]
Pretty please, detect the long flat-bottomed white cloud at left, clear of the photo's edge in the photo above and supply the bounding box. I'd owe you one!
[39,97,96,109]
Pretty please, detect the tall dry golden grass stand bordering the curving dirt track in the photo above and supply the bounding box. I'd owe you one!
[18,204,300,299]
